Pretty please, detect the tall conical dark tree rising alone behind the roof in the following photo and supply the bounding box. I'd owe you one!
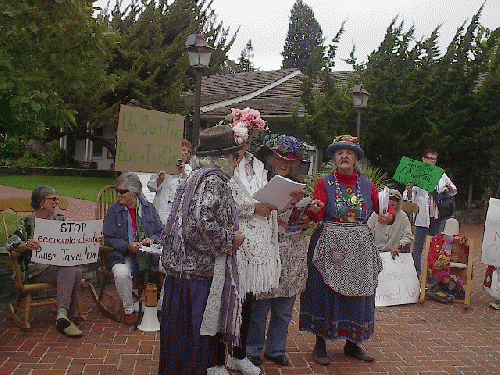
[281,0,324,71]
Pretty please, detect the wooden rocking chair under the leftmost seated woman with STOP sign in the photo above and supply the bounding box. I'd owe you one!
[0,198,81,329]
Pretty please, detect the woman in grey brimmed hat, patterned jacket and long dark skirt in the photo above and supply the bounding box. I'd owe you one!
[159,125,244,375]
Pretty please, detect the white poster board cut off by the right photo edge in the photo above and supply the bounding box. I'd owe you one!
[481,198,500,267]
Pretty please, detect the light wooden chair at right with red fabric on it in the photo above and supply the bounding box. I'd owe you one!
[419,236,474,309]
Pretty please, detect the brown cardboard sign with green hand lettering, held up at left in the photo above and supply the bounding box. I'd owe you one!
[115,105,184,174]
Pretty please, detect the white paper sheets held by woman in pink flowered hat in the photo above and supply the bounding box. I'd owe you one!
[253,176,306,211]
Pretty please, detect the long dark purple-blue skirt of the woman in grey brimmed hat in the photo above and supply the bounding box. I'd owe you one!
[158,276,225,375]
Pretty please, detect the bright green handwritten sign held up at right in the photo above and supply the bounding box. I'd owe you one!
[393,156,444,193]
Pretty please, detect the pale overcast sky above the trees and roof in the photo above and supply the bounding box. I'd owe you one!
[94,0,500,70]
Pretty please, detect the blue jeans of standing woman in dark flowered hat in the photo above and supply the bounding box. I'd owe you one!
[247,297,295,357]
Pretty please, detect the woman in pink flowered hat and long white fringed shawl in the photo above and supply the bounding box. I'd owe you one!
[226,108,281,375]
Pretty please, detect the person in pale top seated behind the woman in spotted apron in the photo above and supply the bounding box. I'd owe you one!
[367,189,413,258]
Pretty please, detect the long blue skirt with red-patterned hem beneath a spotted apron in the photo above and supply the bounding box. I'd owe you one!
[299,227,375,344]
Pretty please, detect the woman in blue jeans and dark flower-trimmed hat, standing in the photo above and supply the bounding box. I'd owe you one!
[246,135,310,366]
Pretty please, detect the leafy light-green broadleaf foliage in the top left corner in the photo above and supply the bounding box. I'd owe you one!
[0,0,116,139]
